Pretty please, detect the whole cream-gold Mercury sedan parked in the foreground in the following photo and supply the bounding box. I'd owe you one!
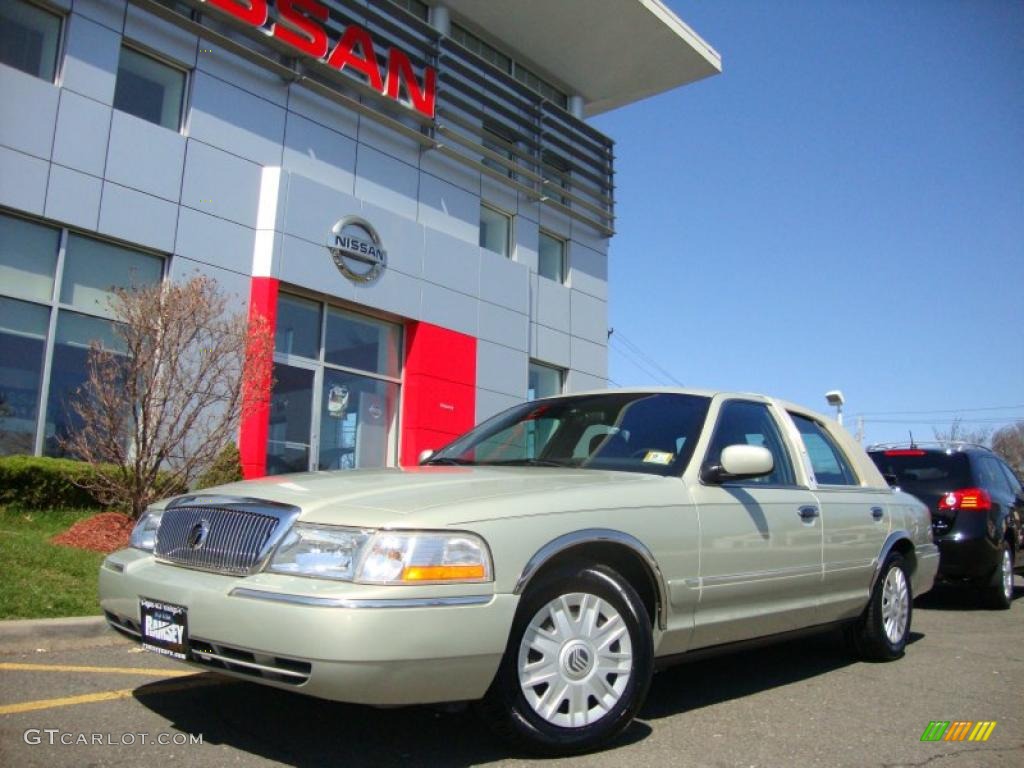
[99,389,938,754]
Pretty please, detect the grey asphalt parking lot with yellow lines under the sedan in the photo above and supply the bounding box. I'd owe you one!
[0,578,1024,768]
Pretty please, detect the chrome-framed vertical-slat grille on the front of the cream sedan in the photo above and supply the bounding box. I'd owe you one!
[156,505,282,575]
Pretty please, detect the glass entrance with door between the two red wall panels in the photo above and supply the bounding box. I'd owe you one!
[267,294,401,474]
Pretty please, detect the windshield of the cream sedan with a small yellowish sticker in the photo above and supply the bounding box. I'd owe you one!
[425,392,710,475]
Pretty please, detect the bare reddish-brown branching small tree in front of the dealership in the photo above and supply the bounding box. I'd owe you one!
[61,275,273,517]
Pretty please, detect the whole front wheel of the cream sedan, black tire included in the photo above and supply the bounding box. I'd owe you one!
[479,563,653,756]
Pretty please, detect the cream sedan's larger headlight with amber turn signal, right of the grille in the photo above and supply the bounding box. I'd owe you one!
[269,523,492,584]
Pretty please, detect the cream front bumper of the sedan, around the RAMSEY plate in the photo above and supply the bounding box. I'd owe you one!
[99,550,518,706]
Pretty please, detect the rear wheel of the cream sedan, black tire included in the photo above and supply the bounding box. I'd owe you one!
[847,552,913,662]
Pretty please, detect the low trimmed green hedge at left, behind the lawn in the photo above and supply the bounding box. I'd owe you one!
[0,456,110,509]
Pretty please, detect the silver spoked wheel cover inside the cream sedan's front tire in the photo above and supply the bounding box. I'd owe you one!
[516,592,633,728]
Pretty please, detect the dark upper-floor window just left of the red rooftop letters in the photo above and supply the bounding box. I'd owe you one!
[114,46,185,131]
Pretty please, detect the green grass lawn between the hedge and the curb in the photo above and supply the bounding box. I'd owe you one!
[0,508,105,618]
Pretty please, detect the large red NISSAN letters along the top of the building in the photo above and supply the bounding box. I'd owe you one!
[204,0,437,118]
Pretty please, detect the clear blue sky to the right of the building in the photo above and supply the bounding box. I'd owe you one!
[593,0,1024,441]
